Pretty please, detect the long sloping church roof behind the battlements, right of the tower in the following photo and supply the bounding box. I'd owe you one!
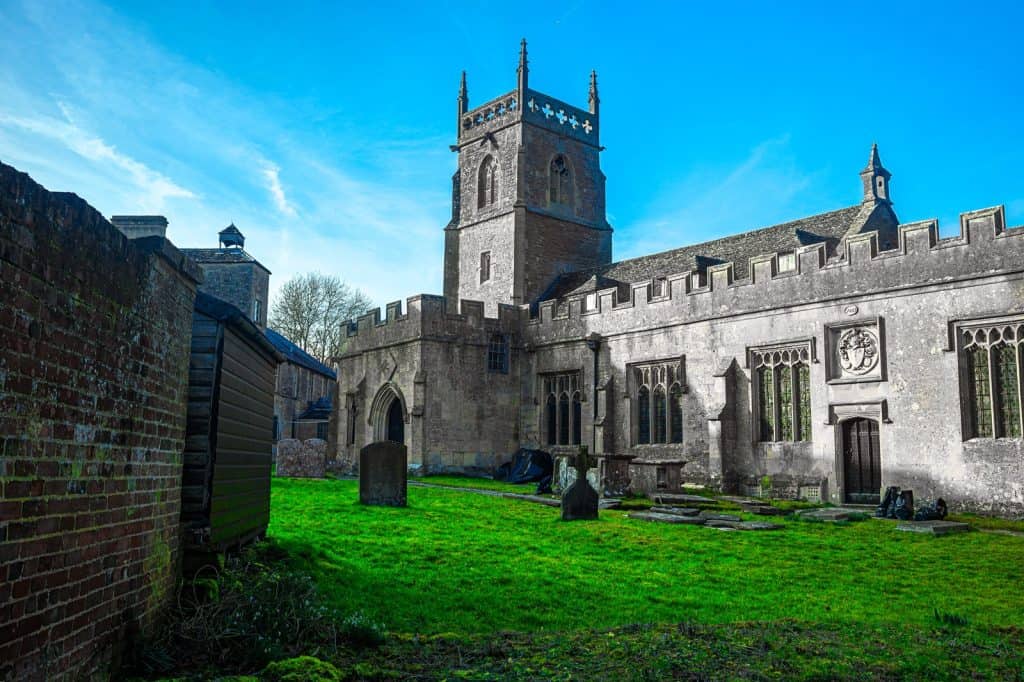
[538,204,869,301]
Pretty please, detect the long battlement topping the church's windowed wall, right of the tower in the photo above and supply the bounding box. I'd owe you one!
[524,206,1024,341]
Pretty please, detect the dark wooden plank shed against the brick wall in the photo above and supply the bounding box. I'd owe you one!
[181,292,282,567]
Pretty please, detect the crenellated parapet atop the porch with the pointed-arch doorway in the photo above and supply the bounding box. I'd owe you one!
[341,294,528,358]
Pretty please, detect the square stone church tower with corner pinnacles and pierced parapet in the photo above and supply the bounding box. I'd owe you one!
[444,40,611,315]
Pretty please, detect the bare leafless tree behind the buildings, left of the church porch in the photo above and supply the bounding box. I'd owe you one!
[269,272,374,363]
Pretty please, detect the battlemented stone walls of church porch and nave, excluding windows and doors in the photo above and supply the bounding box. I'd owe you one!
[340,209,1024,513]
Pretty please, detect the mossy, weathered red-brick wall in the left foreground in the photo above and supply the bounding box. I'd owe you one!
[0,164,201,680]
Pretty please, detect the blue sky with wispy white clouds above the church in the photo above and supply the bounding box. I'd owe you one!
[0,0,1024,303]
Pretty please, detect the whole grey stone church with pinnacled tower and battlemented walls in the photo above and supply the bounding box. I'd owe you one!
[334,42,1024,514]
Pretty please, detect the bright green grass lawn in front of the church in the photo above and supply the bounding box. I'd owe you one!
[269,478,1024,636]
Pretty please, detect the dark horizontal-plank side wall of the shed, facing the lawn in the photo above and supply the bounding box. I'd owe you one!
[210,328,276,548]
